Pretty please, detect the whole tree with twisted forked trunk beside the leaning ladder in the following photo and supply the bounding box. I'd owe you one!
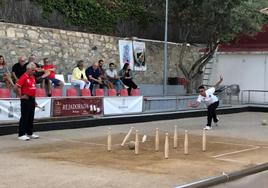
[171,0,267,93]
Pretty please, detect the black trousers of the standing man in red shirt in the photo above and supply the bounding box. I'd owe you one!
[19,97,35,136]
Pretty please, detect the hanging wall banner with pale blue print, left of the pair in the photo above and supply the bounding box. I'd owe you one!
[119,40,134,70]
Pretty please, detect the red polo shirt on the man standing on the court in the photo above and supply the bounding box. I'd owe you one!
[16,72,36,97]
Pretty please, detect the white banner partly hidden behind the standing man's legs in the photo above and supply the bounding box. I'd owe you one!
[0,98,51,121]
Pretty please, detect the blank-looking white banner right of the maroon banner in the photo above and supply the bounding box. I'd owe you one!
[103,96,143,115]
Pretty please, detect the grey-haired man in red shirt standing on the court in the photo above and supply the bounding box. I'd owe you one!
[14,62,39,141]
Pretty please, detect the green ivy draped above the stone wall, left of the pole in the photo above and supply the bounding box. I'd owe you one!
[32,0,156,33]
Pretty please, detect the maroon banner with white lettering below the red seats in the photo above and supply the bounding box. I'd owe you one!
[53,97,103,117]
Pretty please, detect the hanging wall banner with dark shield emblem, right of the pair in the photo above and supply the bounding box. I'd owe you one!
[133,41,146,71]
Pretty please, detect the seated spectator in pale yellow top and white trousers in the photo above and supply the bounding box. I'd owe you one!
[71,60,91,89]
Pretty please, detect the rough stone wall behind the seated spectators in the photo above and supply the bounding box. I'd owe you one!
[0,22,197,84]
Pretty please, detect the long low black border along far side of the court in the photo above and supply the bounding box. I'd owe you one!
[0,106,258,136]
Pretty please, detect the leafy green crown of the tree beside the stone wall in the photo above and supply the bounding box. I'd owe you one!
[172,0,267,43]
